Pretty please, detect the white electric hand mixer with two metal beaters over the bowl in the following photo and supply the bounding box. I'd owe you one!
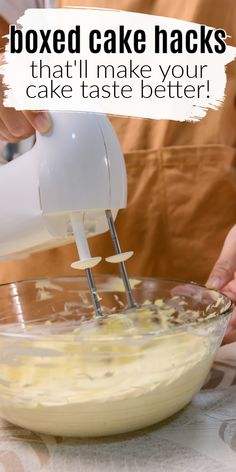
[0,113,137,316]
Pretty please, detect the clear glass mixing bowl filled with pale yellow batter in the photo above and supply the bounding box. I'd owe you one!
[0,276,232,437]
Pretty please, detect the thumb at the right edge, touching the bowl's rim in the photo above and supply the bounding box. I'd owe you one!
[206,225,236,289]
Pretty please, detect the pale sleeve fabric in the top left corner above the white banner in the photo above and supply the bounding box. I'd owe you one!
[0,0,45,23]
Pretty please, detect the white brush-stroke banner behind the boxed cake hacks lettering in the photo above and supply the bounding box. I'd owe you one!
[1,8,236,121]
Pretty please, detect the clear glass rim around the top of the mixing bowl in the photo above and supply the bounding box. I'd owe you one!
[0,274,234,342]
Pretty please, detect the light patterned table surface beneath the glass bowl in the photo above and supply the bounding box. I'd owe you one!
[0,343,236,472]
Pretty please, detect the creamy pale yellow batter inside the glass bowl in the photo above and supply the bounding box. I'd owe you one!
[0,319,213,436]
